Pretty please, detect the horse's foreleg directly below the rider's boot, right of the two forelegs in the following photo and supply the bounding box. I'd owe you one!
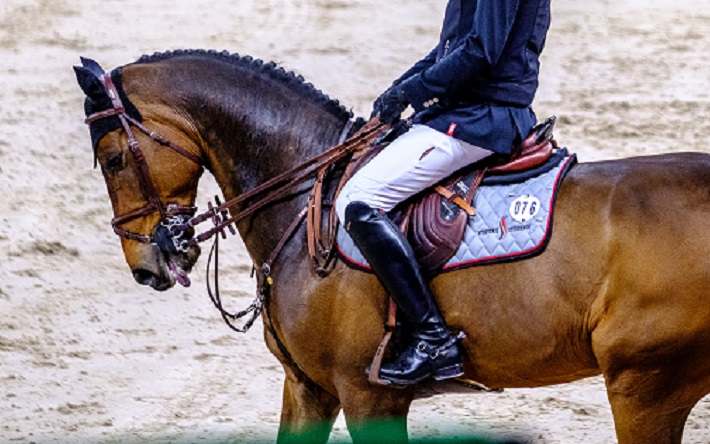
[338,377,414,444]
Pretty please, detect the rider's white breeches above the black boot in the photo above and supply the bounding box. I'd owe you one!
[335,125,493,221]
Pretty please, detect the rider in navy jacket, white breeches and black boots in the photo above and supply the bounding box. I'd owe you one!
[336,0,550,384]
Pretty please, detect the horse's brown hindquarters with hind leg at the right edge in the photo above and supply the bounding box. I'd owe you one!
[590,155,710,444]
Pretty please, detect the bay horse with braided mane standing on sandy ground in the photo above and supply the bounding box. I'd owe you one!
[75,51,710,444]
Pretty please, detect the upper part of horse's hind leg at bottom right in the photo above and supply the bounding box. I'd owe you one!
[607,370,697,444]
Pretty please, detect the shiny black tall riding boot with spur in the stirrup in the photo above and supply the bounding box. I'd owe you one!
[345,202,463,384]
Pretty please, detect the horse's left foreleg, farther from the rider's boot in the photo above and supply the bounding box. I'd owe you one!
[278,369,340,444]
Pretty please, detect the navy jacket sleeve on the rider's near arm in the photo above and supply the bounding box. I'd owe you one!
[401,0,520,111]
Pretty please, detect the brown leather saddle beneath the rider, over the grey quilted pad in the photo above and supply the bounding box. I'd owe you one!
[307,116,557,275]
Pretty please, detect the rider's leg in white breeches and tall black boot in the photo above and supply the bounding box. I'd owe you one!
[336,126,490,384]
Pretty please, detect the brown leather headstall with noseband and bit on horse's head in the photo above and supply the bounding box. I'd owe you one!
[84,72,203,246]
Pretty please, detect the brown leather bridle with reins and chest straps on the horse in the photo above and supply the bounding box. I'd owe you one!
[84,72,389,340]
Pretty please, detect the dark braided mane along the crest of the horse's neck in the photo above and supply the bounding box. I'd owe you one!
[136,49,353,120]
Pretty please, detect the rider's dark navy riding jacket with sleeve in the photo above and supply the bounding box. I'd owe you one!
[395,0,550,154]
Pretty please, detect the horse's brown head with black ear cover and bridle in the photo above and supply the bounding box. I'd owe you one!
[74,59,203,290]
